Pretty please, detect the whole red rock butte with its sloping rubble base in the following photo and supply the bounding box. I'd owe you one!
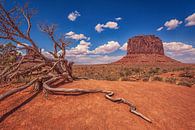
[115,35,181,65]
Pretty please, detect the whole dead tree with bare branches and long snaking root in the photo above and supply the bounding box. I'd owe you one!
[0,3,151,122]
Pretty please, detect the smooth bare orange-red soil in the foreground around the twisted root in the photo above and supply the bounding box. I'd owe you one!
[0,80,195,130]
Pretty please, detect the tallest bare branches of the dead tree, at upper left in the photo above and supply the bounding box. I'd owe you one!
[0,3,40,55]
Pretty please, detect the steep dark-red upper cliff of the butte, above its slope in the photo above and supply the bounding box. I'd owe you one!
[127,35,164,55]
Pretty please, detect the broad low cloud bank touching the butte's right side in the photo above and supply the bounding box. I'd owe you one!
[163,42,195,63]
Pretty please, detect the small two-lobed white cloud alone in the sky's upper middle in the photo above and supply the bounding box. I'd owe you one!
[95,21,119,32]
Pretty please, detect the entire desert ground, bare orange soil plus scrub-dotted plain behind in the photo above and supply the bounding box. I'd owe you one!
[0,61,195,130]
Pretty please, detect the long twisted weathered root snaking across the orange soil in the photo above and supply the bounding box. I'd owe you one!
[0,75,152,123]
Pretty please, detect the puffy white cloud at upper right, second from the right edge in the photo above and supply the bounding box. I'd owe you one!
[164,19,182,30]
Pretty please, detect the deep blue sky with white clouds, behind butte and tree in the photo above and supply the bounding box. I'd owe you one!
[11,0,195,63]
